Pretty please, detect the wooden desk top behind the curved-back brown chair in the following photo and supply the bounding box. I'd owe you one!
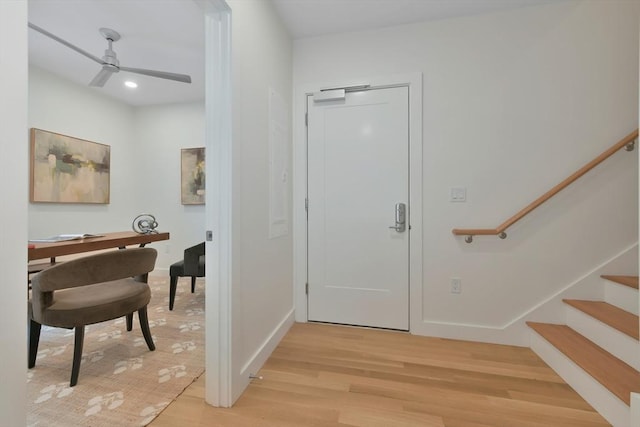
[29,231,169,263]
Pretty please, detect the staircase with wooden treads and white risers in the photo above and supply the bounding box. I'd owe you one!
[527,276,640,427]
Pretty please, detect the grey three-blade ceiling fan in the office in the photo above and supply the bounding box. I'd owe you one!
[29,22,191,87]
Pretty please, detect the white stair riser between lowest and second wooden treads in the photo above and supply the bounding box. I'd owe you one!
[567,306,640,371]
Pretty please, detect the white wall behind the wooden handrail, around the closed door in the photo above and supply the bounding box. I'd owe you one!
[294,1,639,345]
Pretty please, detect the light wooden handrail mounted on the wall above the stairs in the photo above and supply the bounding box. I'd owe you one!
[451,129,638,243]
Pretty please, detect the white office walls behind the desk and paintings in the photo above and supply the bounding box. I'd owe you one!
[29,67,204,274]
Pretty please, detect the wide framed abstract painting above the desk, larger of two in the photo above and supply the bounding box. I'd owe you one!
[29,128,111,204]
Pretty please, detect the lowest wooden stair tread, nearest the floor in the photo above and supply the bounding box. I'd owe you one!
[527,322,640,405]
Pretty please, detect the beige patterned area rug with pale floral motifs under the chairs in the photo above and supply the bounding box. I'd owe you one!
[27,277,204,427]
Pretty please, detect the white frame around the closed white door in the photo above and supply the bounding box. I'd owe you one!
[293,73,423,331]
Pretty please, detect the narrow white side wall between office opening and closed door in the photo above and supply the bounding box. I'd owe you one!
[228,0,293,400]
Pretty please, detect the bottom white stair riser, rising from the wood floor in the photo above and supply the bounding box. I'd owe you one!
[531,331,631,427]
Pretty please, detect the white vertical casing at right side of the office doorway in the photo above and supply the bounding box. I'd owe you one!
[200,0,233,407]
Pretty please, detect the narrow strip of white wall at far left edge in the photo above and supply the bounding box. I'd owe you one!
[0,1,28,426]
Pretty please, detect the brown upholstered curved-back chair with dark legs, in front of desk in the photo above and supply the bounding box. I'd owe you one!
[28,248,157,387]
